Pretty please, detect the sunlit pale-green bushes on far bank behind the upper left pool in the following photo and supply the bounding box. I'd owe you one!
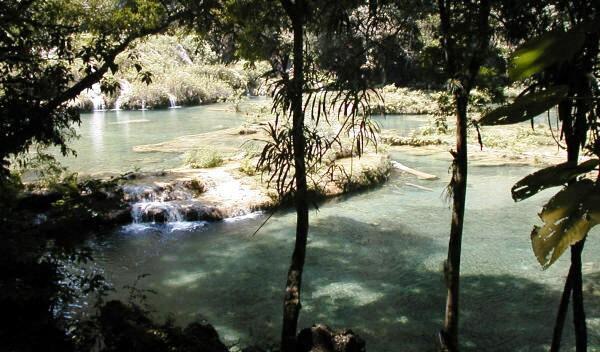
[77,33,268,110]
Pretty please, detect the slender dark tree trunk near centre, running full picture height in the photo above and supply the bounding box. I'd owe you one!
[281,0,308,352]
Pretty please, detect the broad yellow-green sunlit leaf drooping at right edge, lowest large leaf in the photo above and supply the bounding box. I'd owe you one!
[531,179,600,269]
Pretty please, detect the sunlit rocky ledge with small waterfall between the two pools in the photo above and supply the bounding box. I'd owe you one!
[122,154,392,223]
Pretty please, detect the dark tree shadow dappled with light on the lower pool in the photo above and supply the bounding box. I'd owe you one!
[101,215,600,351]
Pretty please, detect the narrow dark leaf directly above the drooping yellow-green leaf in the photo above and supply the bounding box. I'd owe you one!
[511,159,600,202]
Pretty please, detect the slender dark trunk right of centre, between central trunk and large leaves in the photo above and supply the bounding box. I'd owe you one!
[441,92,468,352]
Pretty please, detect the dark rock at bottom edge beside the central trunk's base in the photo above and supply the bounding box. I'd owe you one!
[298,324,366,352]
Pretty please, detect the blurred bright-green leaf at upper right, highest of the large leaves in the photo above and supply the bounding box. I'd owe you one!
[508,26,585,81]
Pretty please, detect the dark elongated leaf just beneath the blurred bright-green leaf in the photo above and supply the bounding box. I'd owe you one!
[478,86,569,126]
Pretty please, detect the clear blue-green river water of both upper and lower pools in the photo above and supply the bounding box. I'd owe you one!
[66,105,600,352]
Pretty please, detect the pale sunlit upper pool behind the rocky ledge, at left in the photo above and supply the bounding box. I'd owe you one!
[56,104,244,173]
